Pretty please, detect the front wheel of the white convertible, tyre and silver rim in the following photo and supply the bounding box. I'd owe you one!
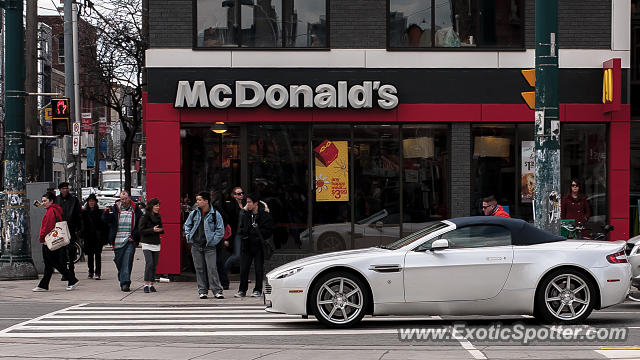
[311,272,369,328]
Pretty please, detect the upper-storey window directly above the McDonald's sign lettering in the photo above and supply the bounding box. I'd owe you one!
[195,0,329,48]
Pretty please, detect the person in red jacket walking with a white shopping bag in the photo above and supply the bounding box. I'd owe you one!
[33,191,78,292]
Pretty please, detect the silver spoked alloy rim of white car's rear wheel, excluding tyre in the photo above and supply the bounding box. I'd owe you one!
[544,274,591,320]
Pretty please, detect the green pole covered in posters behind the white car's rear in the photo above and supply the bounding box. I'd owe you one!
[533,0,561,234]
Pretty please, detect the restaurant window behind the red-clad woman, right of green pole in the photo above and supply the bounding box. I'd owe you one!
[560,124,608,232]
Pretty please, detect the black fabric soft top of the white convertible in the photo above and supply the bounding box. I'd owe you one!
[448,216,566,245]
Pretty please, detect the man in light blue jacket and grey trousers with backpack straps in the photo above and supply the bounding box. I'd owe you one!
[184,191,224,299]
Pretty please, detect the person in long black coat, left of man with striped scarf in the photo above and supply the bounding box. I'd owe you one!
[80,194,107,280]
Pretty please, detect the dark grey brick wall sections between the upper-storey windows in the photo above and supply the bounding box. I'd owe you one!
[149,0,622,49]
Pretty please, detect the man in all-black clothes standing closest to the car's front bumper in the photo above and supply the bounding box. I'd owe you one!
[235,194,273,297]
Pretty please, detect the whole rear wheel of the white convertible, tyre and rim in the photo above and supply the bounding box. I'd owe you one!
[535,269,597,324]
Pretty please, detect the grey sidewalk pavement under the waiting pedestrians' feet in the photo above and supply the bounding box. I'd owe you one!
[0,247,263,305]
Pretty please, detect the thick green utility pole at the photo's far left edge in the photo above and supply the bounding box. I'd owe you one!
[0,0,38,280]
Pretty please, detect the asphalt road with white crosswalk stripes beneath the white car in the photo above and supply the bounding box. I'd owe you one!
[0,302,640,360]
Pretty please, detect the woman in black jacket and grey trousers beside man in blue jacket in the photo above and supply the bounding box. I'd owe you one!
[139,198,164,293]
